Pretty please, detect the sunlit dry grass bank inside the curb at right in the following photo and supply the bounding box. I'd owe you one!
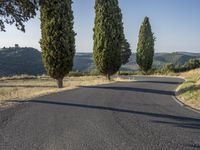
[177,69,200,109]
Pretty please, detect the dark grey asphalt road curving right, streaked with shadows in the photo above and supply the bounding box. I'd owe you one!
[0,77,200,150]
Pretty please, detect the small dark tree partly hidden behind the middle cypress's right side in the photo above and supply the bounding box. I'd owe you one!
[121,39,132,65]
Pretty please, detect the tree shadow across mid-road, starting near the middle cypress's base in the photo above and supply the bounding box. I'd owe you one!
[80,86,175,96]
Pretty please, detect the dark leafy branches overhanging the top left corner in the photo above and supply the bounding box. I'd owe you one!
[0,0,38,32]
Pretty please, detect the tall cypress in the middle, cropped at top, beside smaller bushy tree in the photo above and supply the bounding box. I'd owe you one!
[93,0,124,80]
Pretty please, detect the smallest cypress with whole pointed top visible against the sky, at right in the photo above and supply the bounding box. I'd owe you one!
[136,17,155,72]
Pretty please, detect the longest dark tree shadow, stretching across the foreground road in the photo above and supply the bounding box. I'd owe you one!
[10,100,200,129]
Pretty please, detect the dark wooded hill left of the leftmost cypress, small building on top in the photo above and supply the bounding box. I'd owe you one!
[0,47,45,76]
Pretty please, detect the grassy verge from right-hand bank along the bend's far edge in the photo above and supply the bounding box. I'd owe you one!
[119,69,200,110]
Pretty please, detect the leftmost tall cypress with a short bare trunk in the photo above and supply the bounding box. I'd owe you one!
[40,0,75,88]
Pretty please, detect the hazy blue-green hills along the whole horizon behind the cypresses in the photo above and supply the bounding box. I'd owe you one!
[0,47,200,76]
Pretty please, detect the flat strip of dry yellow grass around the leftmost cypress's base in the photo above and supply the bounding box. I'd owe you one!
[0,76,113,106]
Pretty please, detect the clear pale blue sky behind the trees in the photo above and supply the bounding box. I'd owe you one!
[0,0,200,52]
